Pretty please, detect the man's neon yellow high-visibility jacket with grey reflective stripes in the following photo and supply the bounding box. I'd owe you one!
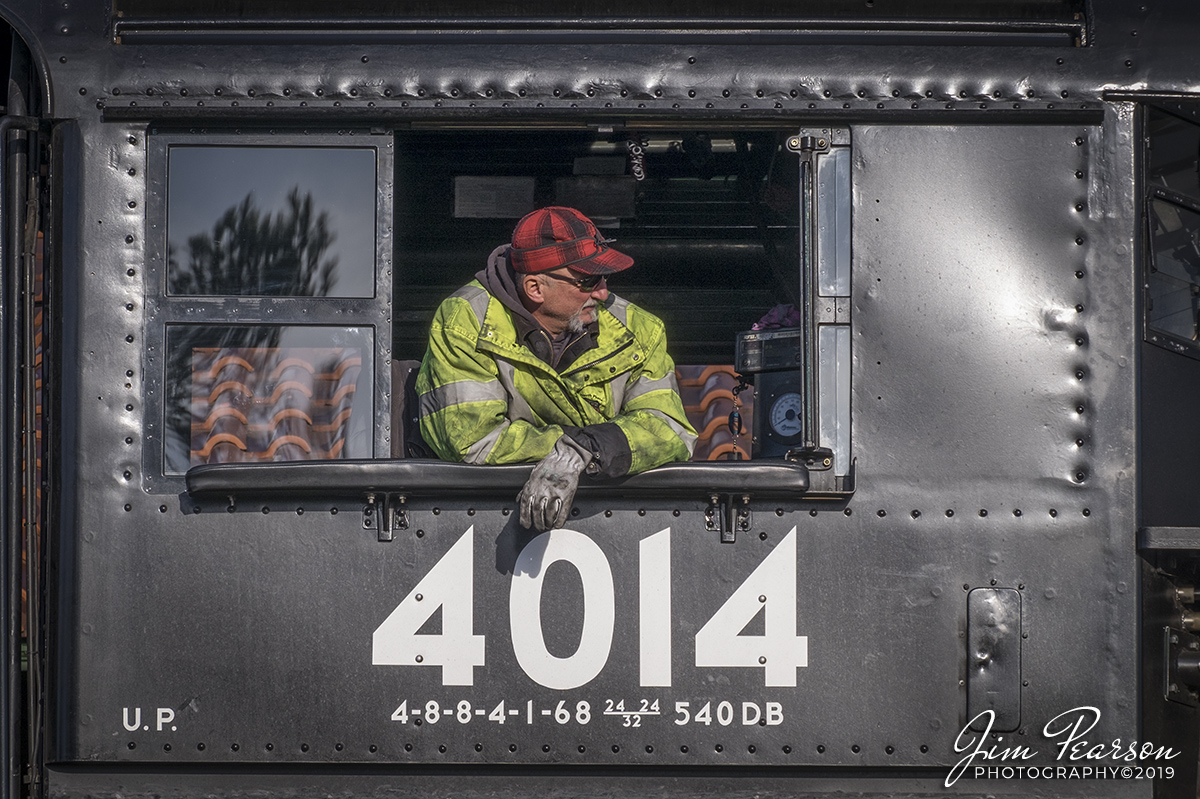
[416,281,696,474]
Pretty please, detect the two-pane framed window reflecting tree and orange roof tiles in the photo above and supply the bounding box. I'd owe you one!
[145,131,391,486]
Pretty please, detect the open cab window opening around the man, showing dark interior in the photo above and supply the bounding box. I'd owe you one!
[392,128,851,488]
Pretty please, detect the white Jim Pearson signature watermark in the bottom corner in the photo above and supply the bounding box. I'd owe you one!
[946,705,1180,788]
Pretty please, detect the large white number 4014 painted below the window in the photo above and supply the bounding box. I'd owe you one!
[371,527,809,690]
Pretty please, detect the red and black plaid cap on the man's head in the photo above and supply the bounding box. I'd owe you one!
[509,205,634,275]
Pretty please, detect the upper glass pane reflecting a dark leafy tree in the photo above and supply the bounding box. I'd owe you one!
[167,145,377,298]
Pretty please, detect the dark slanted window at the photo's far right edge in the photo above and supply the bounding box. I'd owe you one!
[1148,199,1200,341]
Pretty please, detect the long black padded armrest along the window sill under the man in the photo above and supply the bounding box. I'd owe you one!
[186,458,809,498]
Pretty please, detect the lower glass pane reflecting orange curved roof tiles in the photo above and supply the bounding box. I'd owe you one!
[166,325,372,474]
